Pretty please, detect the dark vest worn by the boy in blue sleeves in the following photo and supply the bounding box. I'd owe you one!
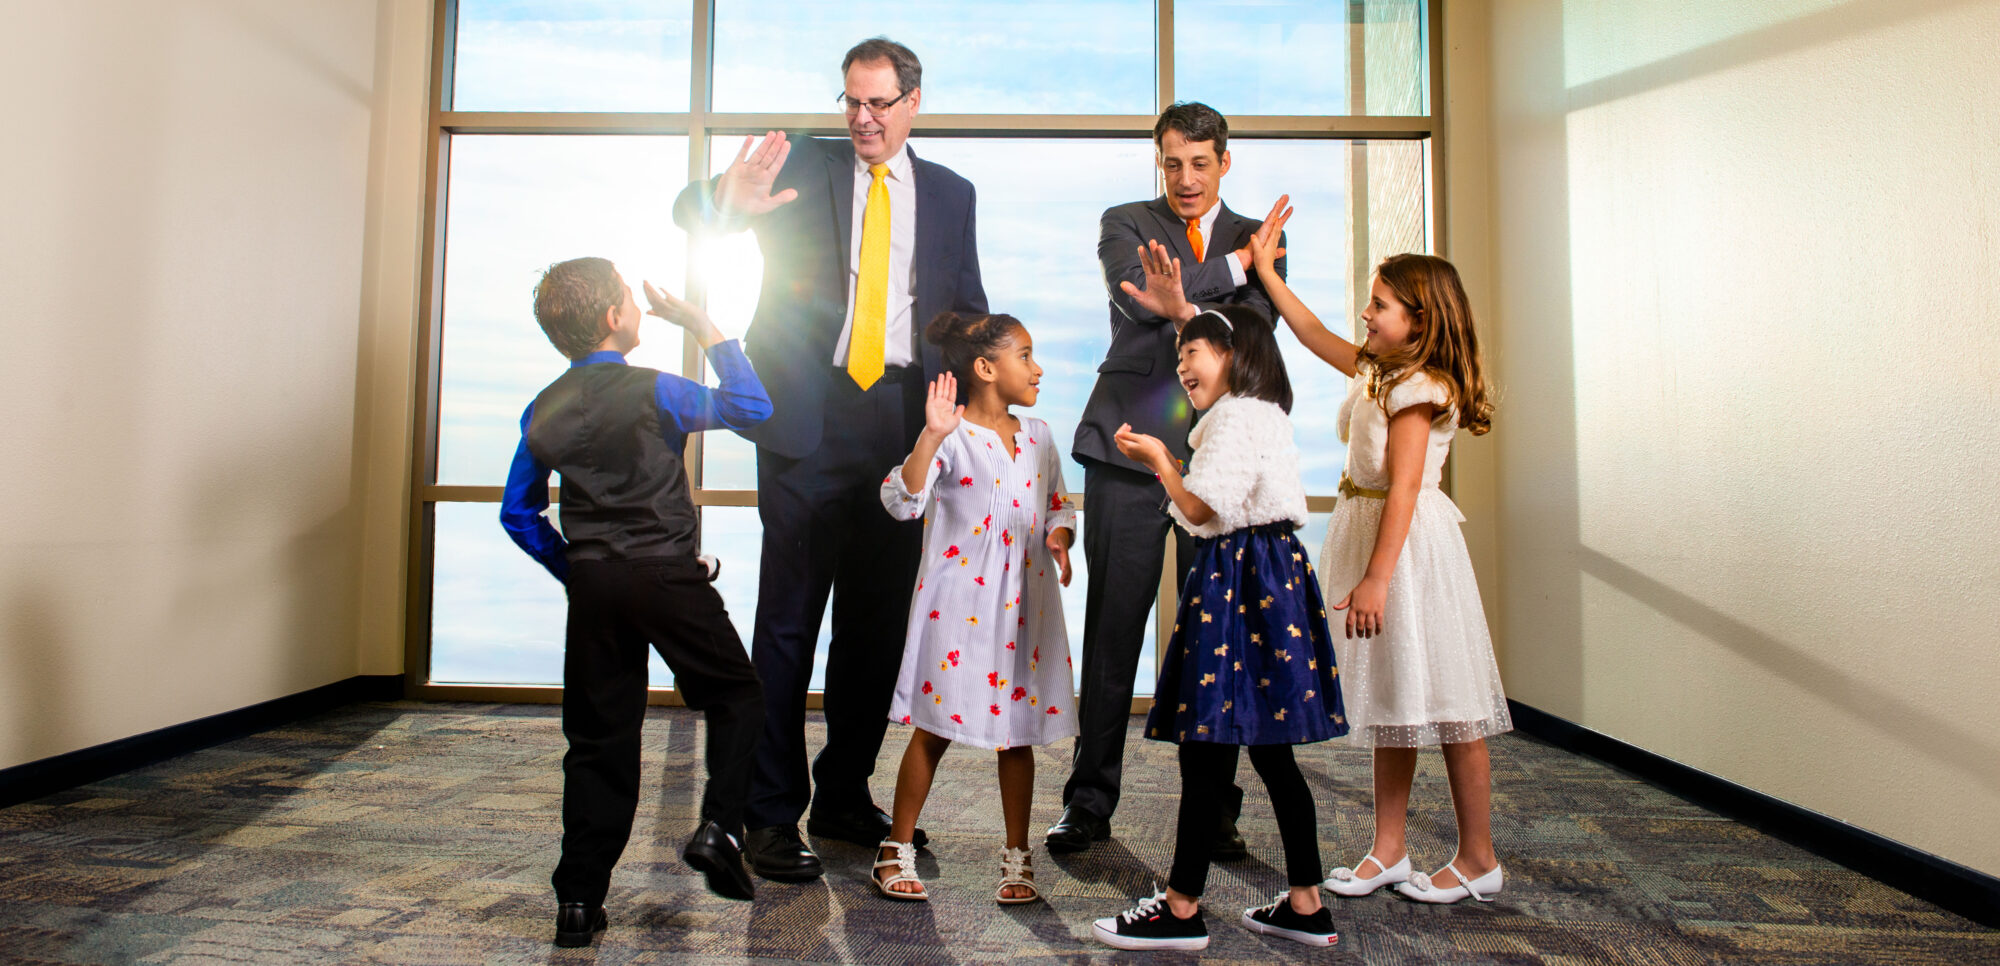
[528,364,696,562]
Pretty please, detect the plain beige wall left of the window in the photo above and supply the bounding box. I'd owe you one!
[0,0,428,766]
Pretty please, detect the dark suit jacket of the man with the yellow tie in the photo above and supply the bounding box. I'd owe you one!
[674,138,986,458]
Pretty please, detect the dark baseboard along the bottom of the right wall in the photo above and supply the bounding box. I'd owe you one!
[1508,700,2000,928]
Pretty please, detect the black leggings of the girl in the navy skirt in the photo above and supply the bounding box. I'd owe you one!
[1166,742,1324,896]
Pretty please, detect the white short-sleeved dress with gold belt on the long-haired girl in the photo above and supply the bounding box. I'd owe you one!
[1320,374,1514,748]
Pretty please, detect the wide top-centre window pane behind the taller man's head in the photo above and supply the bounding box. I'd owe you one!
[712,0,1156,116]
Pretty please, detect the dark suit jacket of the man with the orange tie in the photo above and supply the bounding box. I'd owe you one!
[1070,196,1284,472]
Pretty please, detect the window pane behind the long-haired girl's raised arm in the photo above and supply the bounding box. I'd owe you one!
[1222,138,1428,496]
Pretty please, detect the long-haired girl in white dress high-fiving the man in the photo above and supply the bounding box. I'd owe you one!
[1252,198,1514,902]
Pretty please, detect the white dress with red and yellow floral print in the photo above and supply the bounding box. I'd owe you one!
[882,416,1080,750]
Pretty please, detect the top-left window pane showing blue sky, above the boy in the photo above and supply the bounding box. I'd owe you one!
[452,0,694,112]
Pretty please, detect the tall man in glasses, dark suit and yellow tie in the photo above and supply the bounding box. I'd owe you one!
[674,38,986,882]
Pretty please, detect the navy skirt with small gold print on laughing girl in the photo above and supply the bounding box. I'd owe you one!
[1146,522,1348,744]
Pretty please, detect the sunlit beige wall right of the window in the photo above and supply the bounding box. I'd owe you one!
[1452,0,2000,874]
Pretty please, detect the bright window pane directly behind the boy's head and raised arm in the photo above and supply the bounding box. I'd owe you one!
[438,136,688,486]
